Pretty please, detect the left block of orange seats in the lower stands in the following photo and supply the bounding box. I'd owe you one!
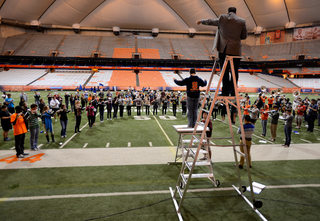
[108,71,136,87]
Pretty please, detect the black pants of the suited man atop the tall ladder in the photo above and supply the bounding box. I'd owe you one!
[219,51,240,96]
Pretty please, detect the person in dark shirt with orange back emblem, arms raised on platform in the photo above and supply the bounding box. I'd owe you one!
[173,68,207,128]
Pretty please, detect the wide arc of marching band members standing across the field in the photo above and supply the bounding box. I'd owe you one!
[0,87,320,157]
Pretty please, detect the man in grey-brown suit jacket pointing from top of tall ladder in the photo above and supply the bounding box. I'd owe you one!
[196,7,247,96]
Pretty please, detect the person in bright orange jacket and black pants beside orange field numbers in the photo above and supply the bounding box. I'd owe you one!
[11,106,29,158]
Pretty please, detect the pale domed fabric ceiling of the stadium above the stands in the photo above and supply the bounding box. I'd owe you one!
[0,0,320,32]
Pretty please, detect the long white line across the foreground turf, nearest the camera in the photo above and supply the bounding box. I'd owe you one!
[0,184,320,202]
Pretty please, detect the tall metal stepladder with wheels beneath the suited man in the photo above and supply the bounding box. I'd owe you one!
[169,56,266,220]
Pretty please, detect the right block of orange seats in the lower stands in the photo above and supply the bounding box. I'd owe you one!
[139,71,168,87]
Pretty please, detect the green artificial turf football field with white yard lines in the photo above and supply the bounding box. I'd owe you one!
[0,91,320,220]
